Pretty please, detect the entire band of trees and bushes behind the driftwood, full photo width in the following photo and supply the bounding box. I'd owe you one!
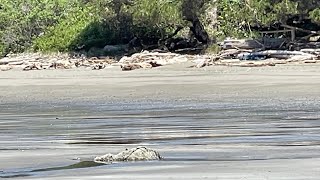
[0,0,320,56]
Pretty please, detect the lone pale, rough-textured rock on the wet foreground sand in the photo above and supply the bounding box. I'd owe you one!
[94,147,162,163]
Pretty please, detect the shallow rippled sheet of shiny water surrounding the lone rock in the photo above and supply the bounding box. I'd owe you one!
[0,100,320,179]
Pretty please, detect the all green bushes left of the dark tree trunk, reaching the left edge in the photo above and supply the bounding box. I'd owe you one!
[0,0,182,54]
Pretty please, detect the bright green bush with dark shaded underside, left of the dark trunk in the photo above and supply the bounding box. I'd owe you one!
[33,0,185,51]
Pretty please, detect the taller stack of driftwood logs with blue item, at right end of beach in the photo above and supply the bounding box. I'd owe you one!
[196,40,320,67]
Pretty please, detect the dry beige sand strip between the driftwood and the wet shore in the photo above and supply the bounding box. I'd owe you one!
[0,64,320,103]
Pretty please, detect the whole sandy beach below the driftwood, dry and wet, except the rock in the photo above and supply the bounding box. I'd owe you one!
[0,64,320,179]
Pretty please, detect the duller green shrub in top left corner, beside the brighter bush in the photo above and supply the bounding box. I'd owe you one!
[0,0,75,54]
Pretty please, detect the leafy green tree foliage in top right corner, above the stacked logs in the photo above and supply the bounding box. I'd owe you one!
[217,0,320,37]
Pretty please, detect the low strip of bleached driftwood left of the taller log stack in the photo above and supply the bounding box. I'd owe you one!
[0,51,212,71]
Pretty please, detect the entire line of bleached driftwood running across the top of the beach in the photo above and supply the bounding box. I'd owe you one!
[0,40,320,71]
